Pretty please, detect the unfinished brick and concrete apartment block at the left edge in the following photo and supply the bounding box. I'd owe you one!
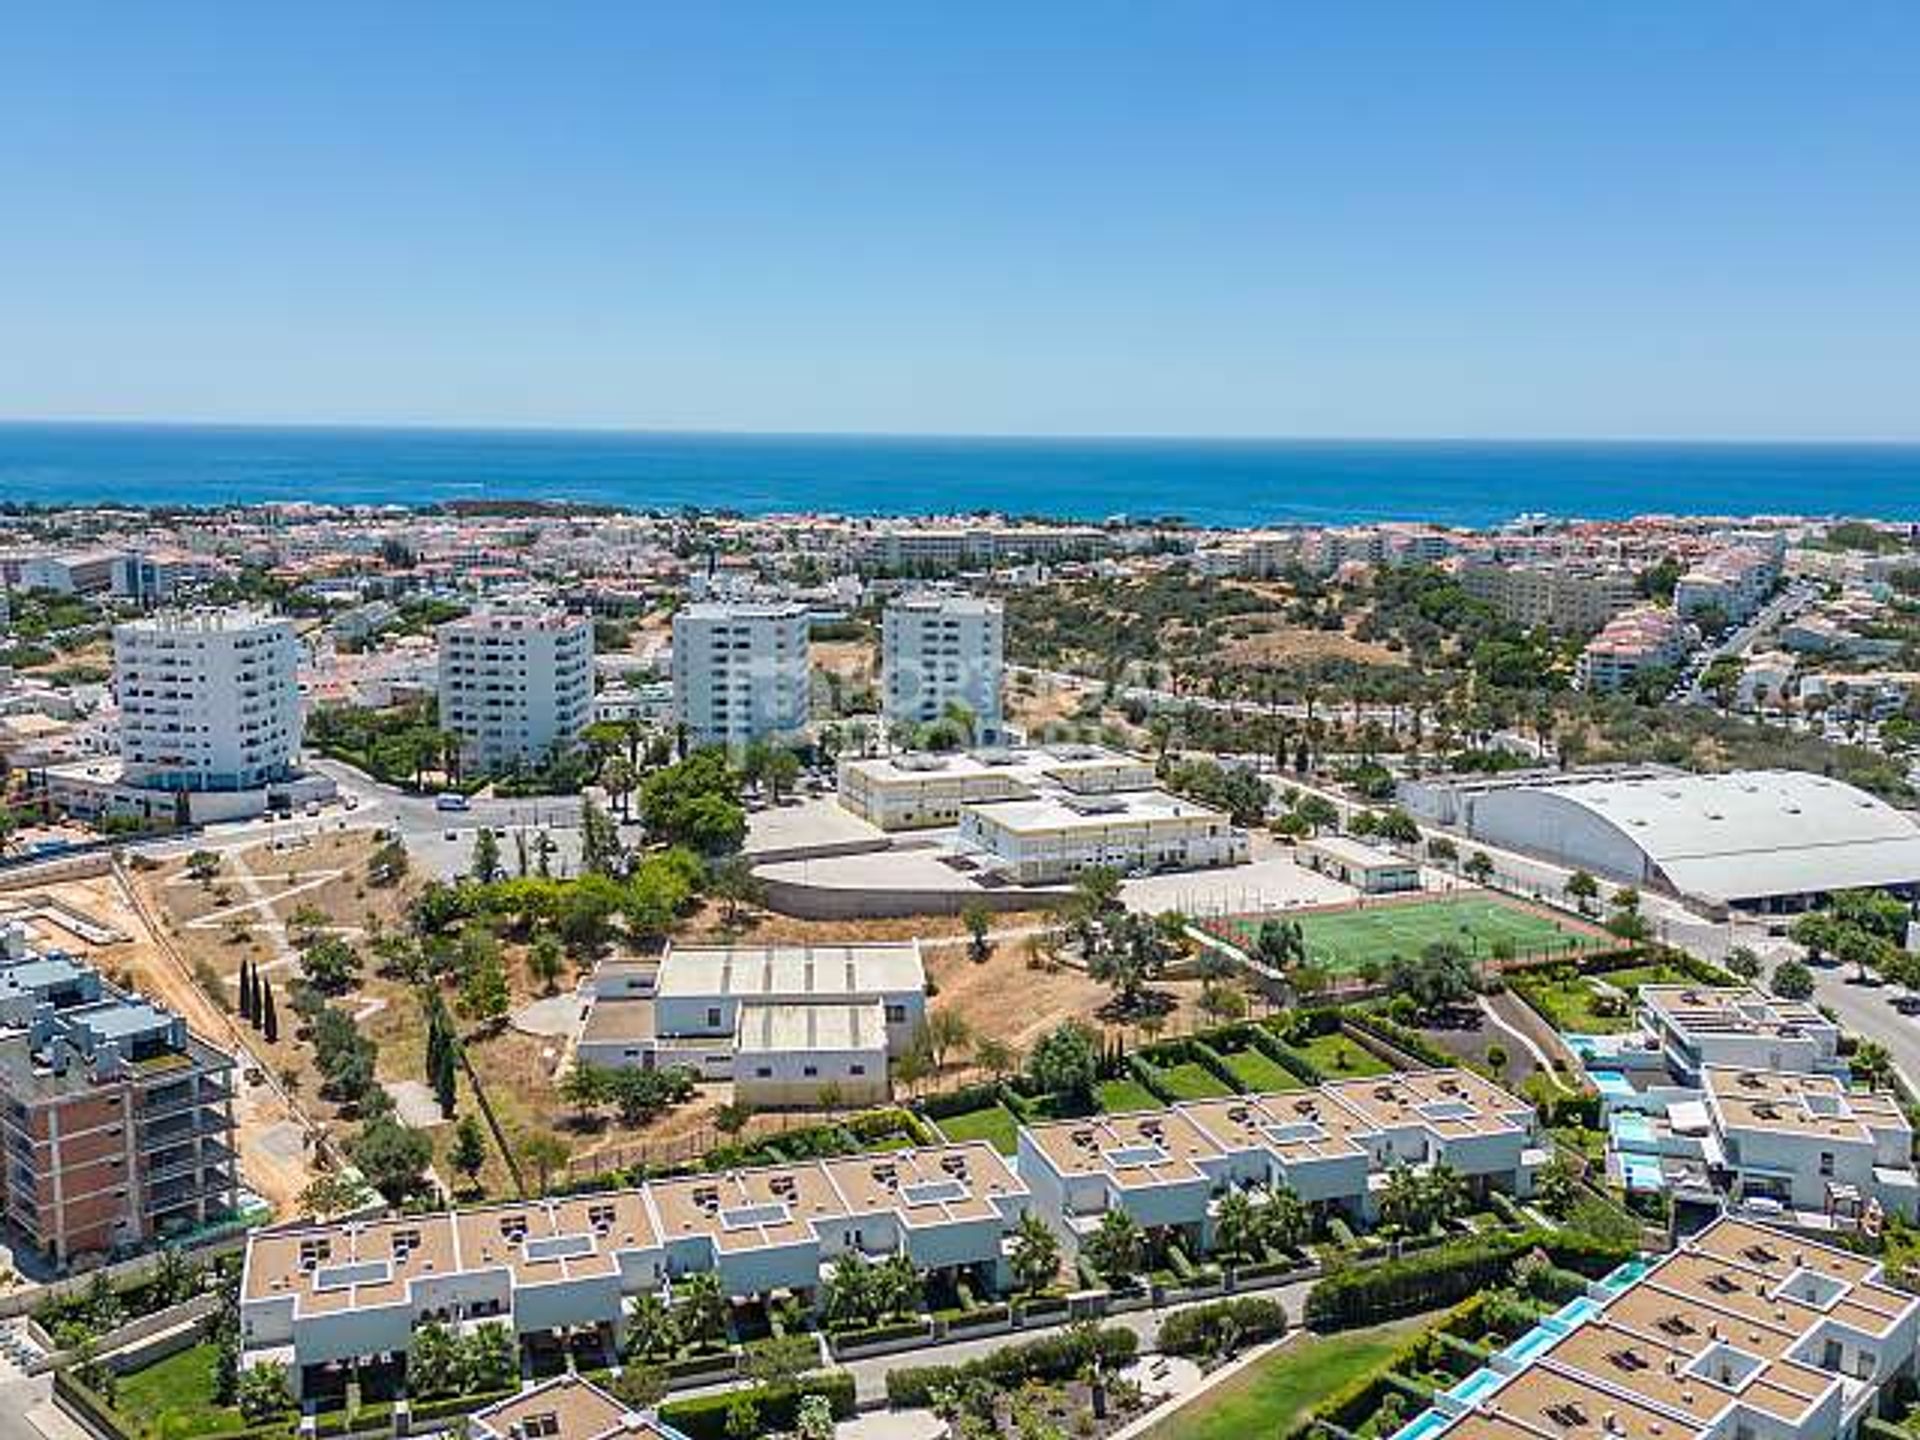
[0,924,238,1265]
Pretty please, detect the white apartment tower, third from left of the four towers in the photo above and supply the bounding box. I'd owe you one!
[674,601,812,745]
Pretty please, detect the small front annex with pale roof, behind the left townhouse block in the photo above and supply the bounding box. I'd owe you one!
[733,1000,887,1108]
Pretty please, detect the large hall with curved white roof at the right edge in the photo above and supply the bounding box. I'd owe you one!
[1476,770,1920,902]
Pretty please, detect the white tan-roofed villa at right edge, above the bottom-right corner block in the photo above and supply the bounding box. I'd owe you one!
[1703,1066,1920,1219]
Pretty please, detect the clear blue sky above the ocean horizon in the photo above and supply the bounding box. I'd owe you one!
[0,0,1920,438]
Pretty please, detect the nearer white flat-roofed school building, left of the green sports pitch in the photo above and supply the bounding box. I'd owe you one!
[960,789,1250,885]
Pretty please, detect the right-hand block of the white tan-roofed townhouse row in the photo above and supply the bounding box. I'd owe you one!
[1018,1069,1548,1250]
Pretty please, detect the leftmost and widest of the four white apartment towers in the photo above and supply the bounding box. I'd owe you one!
[113,609,300,791]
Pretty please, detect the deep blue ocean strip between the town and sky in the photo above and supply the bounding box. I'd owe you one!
[0,424,1920,526]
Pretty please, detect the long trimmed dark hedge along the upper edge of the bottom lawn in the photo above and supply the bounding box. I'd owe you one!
[1306,1231,1634,1331]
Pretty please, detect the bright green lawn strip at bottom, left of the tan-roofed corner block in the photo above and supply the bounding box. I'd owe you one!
[1146,1315,1430,1440]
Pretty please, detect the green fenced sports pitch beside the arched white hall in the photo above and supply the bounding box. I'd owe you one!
[1217,895,1603,972]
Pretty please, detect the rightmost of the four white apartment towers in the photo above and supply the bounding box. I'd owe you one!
[881,591,1004,745]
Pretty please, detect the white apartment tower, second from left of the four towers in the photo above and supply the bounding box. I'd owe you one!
[440,607,593,772]
